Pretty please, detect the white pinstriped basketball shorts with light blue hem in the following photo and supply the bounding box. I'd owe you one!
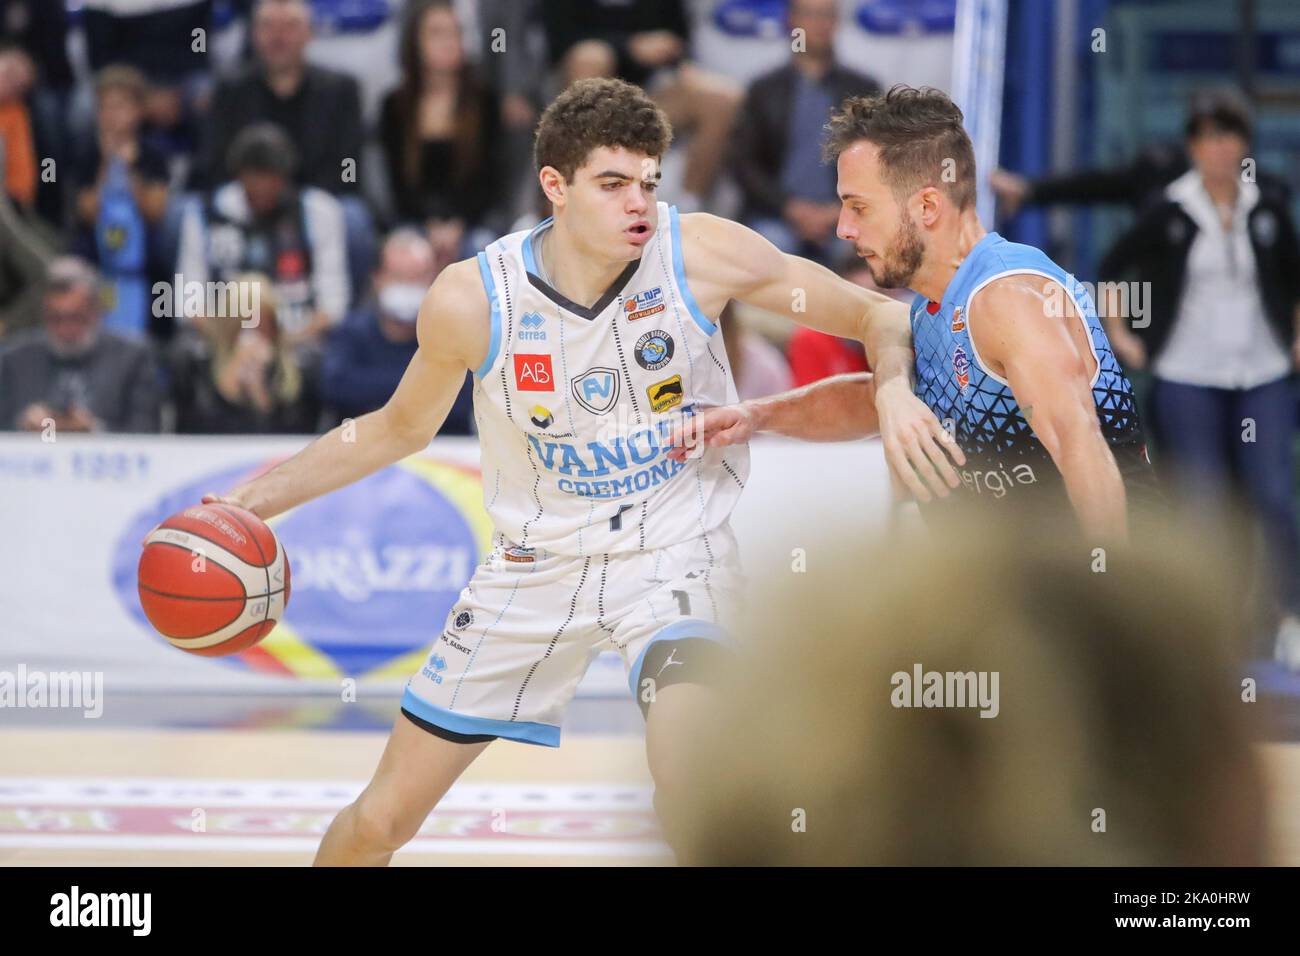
[402,524,744,747]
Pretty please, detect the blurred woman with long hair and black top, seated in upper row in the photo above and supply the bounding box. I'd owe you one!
[380,0,510,263]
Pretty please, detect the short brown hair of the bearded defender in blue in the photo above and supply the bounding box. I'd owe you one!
[823,83,975,209]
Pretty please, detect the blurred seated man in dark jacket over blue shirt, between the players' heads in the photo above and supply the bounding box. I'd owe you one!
[731,0,880,261]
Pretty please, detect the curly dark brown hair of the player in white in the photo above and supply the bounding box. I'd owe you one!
[533,78,672,181]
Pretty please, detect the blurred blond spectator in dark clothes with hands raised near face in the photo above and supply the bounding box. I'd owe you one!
[172,273,320,434]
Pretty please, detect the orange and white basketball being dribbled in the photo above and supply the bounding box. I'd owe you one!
[137,505,289,657]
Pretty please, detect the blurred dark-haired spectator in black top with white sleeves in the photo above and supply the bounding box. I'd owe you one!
[178,124,350,360]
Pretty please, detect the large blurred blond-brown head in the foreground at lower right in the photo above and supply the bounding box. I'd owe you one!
[664,523,1265,865]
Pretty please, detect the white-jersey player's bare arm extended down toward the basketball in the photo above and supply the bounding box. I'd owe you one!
[204,259,489,519]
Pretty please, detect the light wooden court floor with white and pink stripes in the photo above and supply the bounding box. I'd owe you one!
[0,728,1300,866]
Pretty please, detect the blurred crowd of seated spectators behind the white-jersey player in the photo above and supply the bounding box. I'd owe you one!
[0,0,894,434]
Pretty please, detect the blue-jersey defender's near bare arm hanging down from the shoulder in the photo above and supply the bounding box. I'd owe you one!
[967,276,1128,541]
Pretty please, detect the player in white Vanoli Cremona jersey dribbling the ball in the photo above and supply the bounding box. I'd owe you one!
[205,79,957,865]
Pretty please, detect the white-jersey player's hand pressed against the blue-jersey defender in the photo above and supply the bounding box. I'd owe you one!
[876,382,966,502]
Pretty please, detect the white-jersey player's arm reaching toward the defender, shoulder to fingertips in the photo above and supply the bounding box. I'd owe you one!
[681,213,966,501]
